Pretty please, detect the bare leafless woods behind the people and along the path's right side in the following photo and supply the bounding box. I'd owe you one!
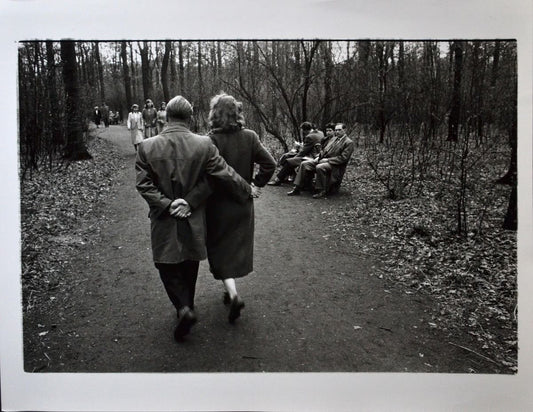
[18,40,517,372]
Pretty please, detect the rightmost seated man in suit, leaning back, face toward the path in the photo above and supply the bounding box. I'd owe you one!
[287,123,354,199]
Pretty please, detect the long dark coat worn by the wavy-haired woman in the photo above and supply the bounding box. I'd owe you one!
[206,129,276,279]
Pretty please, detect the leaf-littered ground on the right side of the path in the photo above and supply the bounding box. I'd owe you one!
[322,148,517,372]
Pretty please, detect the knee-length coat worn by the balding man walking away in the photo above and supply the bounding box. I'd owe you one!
[135,123,251,263]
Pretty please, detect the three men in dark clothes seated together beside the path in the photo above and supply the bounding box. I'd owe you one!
[268,122,354,199]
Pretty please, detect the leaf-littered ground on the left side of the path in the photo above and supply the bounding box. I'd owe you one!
[21,135,119,311]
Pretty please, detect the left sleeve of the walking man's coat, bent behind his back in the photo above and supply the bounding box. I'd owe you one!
[135,144,172,218]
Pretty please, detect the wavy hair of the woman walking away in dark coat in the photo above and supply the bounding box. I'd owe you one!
[209,92,245,131]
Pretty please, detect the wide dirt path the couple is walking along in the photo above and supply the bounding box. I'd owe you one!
[24,126,492,373]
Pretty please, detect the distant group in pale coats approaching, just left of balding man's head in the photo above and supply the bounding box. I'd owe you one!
[127,99,167,150]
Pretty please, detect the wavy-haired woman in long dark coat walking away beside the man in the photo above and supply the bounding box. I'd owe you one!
[206,93,276,323]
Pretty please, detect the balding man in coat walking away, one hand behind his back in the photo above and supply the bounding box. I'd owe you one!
[135,96,252,340]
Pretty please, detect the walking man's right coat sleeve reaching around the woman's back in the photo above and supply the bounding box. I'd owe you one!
[206,142,252,203]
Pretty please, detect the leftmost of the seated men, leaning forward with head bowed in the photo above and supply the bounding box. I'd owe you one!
[268,122,324,186]
